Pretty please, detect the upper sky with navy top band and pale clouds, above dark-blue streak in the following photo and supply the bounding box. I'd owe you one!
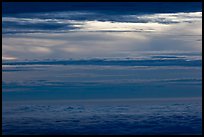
[2,2,202,61]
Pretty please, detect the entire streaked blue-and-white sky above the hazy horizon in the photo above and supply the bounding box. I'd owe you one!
[2,2,202,100]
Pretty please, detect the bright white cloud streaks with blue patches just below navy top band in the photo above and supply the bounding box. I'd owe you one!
[2,12,202,33]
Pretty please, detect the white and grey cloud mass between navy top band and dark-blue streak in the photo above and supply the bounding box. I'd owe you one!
[2,12,202,60]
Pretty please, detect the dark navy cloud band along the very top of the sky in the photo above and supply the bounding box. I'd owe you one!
[2,2,202,14]
